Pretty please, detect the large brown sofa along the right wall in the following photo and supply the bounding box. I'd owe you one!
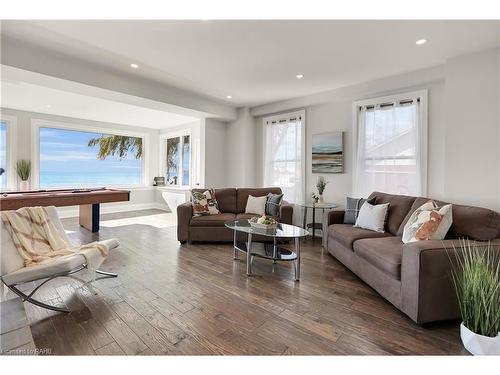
[323,192,500,324]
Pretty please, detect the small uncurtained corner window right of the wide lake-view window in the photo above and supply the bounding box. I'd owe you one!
[165,135,191,186]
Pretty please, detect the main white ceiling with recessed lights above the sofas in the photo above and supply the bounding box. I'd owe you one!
[2,21,499,106]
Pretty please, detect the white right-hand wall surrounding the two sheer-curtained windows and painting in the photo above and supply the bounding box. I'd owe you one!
[250,50,500,209]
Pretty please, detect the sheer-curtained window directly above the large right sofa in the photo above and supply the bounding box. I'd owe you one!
[354,92,427,197]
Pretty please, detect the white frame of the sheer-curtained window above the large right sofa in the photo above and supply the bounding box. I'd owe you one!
[351,89,429,196]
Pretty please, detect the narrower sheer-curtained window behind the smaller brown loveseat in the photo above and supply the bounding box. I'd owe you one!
[264,112,305,203]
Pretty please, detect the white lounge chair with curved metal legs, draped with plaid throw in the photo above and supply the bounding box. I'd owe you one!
[0,207,119,313]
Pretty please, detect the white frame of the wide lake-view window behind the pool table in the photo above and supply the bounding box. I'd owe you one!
[31,118,151,189]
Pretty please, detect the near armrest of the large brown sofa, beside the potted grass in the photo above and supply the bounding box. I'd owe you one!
[401,240,500,324]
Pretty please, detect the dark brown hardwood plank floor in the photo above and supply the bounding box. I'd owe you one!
[4,210,466,355]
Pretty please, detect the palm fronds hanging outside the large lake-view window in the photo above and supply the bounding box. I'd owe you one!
[88,134,142,160]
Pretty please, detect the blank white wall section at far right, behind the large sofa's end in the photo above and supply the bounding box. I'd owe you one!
[444,50,500,209]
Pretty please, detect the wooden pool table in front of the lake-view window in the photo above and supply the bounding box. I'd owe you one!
[0,188,130,232]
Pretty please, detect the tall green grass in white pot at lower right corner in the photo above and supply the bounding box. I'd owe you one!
[452,240,500,355]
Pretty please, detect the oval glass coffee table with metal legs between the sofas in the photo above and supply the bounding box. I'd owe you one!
[224,220,309,281]
